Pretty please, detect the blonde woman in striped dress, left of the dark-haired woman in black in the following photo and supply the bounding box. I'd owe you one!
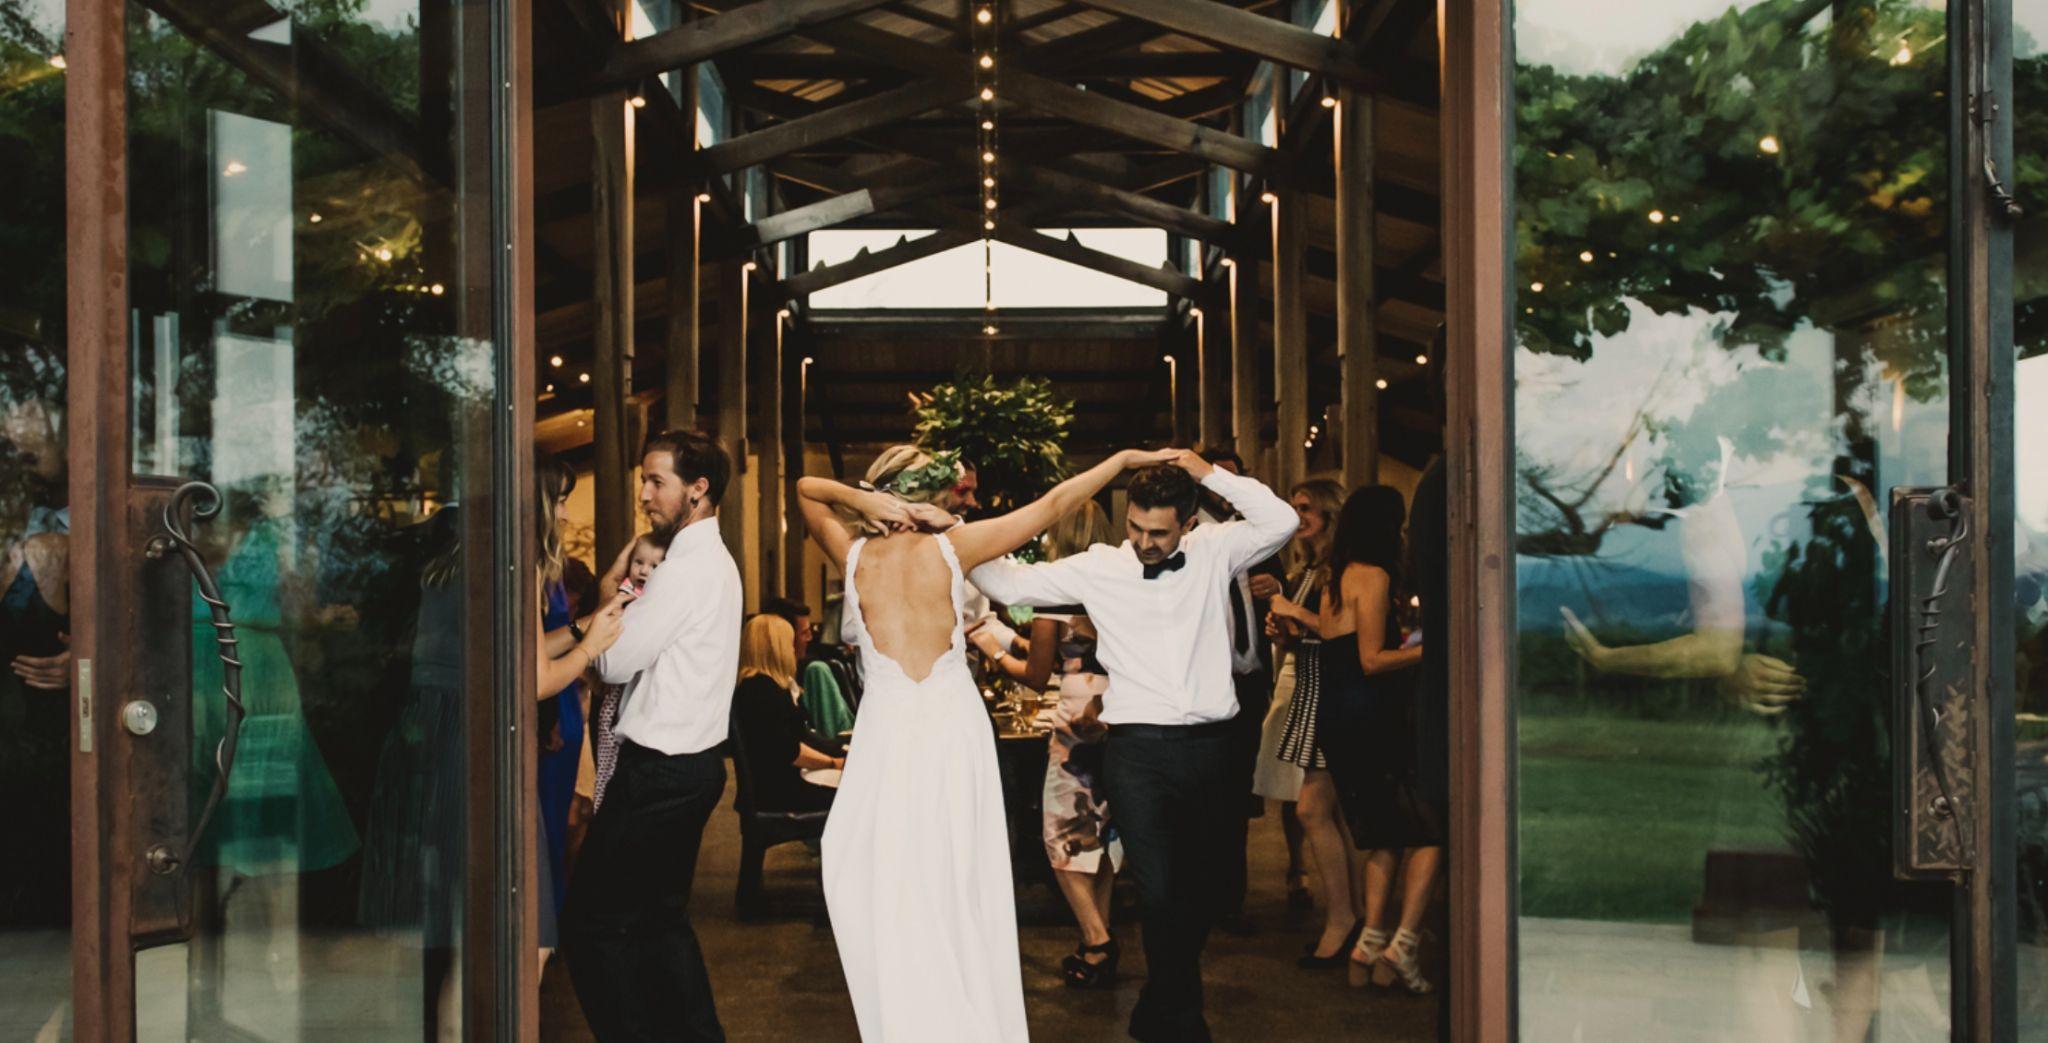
[1251,477,1350,910]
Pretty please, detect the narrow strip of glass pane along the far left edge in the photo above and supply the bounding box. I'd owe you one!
[0,0,72,1039]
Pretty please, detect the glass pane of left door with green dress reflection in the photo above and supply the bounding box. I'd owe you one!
[129,0,494,1028]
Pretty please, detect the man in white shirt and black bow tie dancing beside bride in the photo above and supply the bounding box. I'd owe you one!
[973,451,1296,1043]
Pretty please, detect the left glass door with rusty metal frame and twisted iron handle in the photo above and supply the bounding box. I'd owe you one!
[60,0,518,1041]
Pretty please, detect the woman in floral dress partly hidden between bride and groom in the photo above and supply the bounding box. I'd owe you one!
[975,500,1124,988]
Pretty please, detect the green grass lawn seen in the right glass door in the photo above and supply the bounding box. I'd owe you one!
[1520,713,1786,922]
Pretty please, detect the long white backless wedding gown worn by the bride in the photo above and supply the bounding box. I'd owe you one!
[823,535,1028,1043]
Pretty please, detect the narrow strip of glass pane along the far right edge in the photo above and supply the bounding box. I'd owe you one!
[2013,0,2048,1041]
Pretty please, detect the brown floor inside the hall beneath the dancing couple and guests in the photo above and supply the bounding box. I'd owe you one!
[541,789,1442,1043]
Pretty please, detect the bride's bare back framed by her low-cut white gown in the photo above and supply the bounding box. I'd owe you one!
[854,533,958,682]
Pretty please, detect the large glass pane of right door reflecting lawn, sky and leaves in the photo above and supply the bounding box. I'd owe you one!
[1513,0,1950,1039]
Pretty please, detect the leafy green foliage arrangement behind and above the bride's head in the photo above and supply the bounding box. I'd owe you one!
[913,377,1073,512]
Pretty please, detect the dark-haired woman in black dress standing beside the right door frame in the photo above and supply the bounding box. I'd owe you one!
[1319,486,1444,992]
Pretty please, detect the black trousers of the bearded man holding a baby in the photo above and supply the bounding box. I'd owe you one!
[561,742,725,1043]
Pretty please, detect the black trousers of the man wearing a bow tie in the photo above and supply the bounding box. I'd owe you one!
[1102,721,1243,1043]
